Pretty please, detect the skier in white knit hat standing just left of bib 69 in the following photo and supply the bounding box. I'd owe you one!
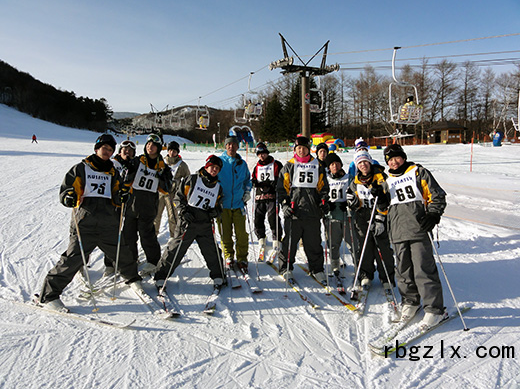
[348,150,395,289]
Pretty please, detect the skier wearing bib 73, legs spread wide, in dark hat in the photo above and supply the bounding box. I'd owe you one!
[154,155,225,289]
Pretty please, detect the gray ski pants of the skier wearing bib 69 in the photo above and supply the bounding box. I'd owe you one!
[393,235,444,314]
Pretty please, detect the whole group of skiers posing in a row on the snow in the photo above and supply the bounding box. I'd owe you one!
[39,134,446,326]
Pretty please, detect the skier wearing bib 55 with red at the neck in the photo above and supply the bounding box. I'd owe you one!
[277,136,329,283]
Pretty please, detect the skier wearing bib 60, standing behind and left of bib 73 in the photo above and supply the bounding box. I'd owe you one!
[123,134,172,274]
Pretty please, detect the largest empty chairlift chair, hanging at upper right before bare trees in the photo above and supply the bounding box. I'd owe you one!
[388,47,422,125]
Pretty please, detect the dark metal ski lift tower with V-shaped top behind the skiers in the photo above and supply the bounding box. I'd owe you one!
[268,33,340,138]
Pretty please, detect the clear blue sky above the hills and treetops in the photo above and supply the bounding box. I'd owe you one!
[0,0,520,112]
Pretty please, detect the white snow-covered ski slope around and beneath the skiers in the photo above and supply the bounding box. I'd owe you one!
[0,105,520,389]
